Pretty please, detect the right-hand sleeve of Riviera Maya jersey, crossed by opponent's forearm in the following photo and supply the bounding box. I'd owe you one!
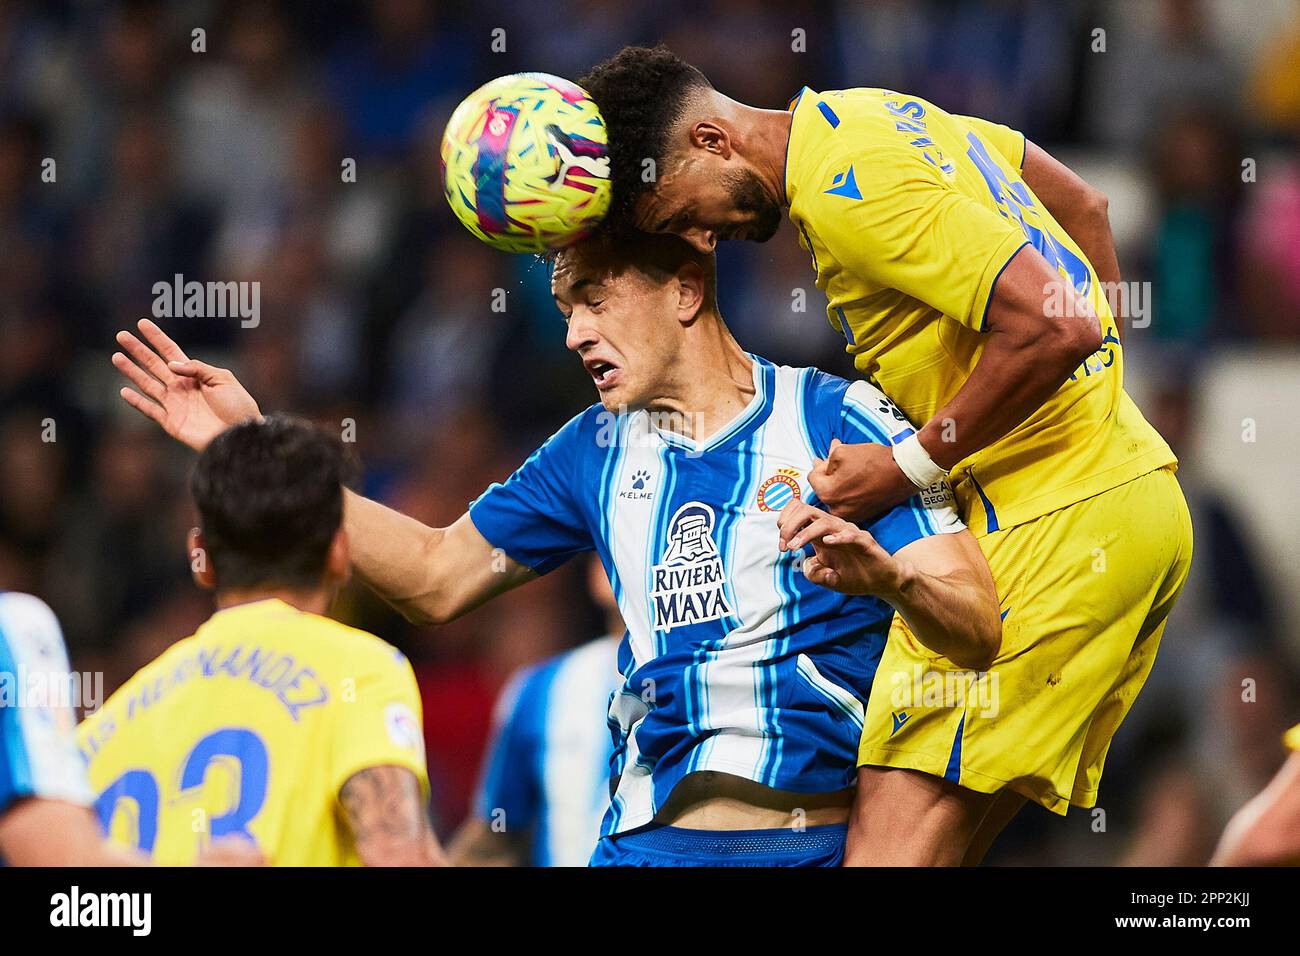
[836,380,966,554]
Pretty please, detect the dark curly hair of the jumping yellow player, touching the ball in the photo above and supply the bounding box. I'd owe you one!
[577,44,712,230]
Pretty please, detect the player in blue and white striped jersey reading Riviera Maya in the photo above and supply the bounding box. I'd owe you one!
[114,235,1001,866]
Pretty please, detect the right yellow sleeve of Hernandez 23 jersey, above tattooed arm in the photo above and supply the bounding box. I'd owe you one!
[330,640,429,795]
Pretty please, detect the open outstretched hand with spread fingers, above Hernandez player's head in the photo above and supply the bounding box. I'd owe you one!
[113,319,261,451]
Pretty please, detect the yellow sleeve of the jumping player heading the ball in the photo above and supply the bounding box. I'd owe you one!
[798,141,1028,330]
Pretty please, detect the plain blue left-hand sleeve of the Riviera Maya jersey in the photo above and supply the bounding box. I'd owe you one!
[469,412,597,574]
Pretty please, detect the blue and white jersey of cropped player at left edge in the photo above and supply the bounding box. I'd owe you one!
[0,591,94,814]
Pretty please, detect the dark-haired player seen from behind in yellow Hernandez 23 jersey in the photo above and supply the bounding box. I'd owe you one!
[78,418,441,866]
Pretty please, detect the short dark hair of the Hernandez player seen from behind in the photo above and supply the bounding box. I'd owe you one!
[190,416,347,588]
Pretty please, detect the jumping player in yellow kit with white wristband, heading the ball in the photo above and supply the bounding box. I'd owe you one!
[579,47,1191,864]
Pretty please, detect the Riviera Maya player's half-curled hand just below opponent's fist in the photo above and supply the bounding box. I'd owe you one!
[776,499,905,597]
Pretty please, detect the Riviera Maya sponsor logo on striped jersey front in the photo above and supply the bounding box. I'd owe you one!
[650,501,732,631]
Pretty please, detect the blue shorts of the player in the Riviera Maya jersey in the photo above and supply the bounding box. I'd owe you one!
[590,823,849,866]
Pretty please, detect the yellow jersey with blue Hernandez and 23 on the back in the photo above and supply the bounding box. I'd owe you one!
[78,600,429,866]
